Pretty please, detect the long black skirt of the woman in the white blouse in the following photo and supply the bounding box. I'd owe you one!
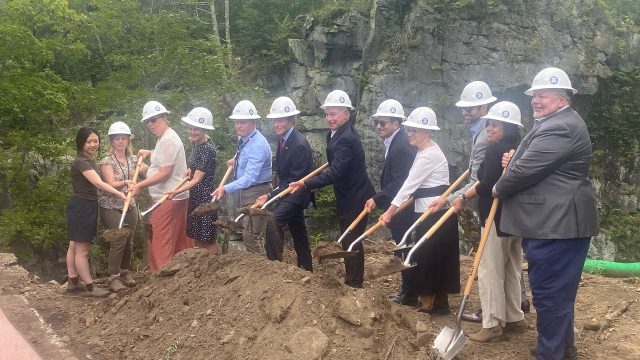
[410,210,460,295]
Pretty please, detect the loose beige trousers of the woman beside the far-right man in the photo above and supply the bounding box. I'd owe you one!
[478,224,524,329]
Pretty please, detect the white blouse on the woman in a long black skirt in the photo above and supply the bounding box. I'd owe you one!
[391,144,449,213]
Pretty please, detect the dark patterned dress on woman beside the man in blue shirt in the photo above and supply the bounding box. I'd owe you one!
[187,138,218,241]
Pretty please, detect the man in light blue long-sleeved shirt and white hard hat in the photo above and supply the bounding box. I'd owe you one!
[211,100,271,253]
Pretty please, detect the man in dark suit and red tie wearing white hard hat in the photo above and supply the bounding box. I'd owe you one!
[258,96,315,272]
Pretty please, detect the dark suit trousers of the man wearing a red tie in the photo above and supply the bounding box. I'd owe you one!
[265,200,313,272]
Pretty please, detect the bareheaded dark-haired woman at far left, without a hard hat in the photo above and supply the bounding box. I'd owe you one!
[65,126,126,297]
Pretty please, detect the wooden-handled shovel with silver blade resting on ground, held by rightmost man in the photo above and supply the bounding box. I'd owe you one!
[433,150,514,360]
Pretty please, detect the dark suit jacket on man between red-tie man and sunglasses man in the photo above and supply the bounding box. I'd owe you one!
[305,121,376,212]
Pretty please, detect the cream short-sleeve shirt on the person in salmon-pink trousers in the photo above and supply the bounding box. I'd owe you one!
[147,128,189,201]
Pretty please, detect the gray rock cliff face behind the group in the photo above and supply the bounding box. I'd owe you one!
[285,0,640,257]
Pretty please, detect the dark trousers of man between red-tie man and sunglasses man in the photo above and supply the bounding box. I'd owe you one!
[338,209,369,287]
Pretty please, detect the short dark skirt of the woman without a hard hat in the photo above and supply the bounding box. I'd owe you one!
[65,196,98,241]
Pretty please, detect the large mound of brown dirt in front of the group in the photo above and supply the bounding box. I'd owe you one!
[68,249,439,360]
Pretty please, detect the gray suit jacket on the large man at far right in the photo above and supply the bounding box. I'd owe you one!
[495,107,598,239]
